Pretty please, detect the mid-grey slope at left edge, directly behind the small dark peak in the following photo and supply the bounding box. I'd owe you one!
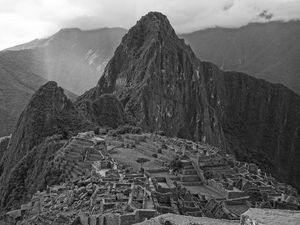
[0,52,76,137]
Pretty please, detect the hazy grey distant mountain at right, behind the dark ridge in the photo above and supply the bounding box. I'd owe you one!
[181,21,300,94]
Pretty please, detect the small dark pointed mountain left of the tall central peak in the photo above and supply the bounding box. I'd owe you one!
[0,81,94,208]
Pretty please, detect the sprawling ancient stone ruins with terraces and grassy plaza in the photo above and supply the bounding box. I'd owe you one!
[1,129,299,225]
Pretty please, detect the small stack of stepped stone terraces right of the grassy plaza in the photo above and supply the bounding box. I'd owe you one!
[179,160,202,186]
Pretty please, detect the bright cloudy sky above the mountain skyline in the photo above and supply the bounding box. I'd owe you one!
[0,0,300,50]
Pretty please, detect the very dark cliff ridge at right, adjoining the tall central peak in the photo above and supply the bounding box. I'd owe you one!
[202,63,300,189]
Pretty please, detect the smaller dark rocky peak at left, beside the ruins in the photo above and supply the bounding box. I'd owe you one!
[0,82,93,210]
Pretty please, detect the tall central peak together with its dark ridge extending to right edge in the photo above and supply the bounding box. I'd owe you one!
[75,12,300,189]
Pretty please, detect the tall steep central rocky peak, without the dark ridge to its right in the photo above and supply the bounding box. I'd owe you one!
[77,13,224,145]
